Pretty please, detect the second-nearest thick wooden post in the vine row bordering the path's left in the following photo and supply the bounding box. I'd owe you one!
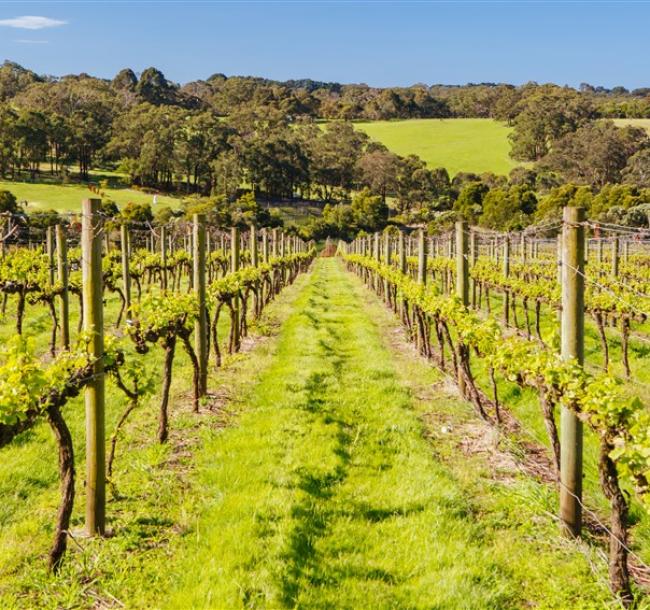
[192,214,208,396]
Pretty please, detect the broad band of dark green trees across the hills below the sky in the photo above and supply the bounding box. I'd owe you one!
[0,62,650,238]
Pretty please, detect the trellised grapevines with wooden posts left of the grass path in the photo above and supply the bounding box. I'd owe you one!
[0,199,315,571]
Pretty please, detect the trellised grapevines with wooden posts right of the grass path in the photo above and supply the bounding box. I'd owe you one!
[339,208,650,604]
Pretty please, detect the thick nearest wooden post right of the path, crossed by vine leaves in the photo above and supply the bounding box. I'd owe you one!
[560,207,585,536]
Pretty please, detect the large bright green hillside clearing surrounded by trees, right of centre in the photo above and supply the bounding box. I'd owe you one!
[355,119,518,176]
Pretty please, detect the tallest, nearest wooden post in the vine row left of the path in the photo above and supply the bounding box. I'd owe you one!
[81,199,106,536]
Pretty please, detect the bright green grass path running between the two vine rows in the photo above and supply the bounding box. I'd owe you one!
[165,259,609,609]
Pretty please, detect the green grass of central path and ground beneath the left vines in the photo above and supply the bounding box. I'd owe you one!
[0,259,615,610]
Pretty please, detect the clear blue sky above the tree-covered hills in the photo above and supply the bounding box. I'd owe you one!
[0,1,650,88]
